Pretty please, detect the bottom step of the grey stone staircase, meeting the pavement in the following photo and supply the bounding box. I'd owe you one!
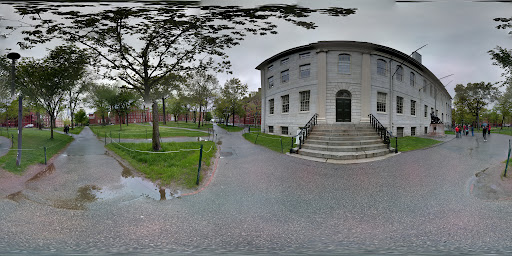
[299,148,392,160]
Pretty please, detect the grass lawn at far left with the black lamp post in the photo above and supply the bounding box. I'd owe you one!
[0,129,73,174]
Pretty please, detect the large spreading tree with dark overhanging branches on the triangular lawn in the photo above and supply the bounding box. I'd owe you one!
[9,2,356,151]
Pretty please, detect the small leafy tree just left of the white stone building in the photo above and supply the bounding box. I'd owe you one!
[221,78,249,126]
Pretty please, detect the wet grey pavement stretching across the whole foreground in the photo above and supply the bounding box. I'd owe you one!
[0,128,512,255]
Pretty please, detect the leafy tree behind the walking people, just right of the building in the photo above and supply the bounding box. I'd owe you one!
[455,82,499,130]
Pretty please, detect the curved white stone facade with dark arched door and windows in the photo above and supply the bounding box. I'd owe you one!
[257,41,452,136]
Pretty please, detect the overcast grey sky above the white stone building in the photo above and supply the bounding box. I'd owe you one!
[0,0,512,97]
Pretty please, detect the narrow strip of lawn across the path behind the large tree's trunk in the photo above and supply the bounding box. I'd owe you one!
[89,124,208,139]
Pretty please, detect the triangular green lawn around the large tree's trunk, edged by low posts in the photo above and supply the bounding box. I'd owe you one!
[107,141,217,188]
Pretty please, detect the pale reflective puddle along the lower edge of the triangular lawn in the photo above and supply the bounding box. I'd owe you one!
[93,158,181,200]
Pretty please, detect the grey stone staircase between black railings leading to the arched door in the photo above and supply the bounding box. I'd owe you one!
[299,123,394,160]
